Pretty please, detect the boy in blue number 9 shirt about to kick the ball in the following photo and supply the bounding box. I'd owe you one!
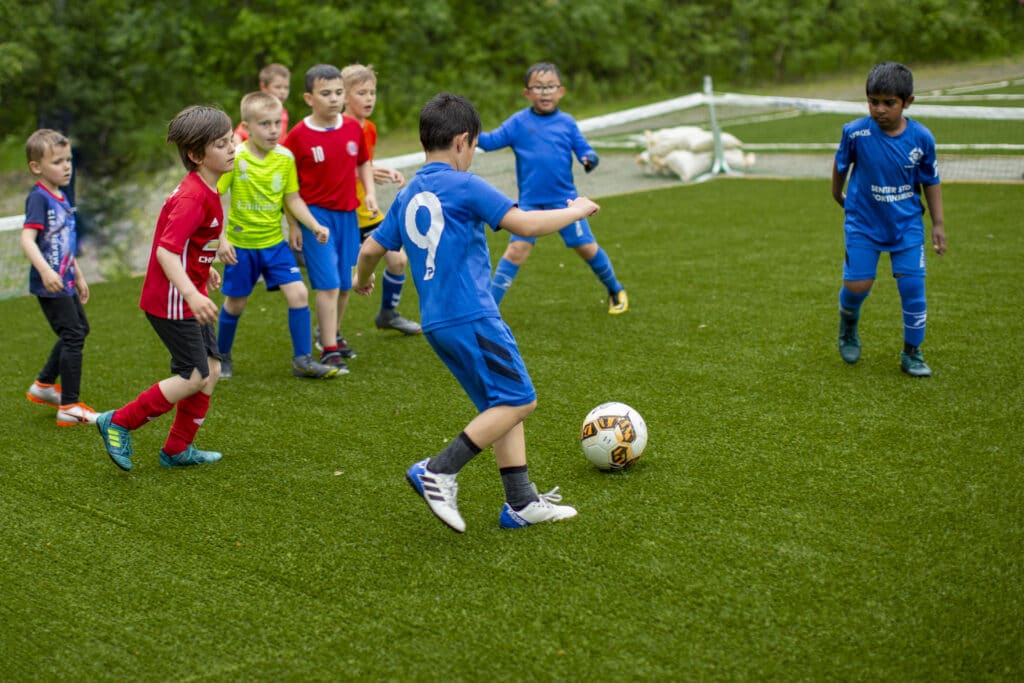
[352,93,599,532]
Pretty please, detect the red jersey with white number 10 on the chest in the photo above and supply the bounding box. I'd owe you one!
[284,114,370,211]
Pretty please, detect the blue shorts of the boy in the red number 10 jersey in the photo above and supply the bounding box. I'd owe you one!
[299,205,359,292]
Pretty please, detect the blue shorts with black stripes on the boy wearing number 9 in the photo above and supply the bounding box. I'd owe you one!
[424,317,537,413]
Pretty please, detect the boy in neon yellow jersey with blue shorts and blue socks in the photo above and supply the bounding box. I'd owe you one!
[217,92,338,379]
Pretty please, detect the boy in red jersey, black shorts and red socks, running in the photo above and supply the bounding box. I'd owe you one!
[96,106,234,470]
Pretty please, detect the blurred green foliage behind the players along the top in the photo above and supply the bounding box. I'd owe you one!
[0,0,1024,176]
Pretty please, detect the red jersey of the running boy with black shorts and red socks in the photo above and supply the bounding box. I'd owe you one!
[138,171,224,321]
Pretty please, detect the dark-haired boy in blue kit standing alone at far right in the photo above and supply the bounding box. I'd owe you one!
[831,61,946,377]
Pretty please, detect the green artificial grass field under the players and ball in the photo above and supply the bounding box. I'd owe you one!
[0,179,1024,681]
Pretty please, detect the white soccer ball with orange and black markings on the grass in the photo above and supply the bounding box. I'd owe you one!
[580,402,647,470]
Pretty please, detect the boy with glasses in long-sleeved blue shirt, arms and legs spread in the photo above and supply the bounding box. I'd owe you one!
[478,61,630,314]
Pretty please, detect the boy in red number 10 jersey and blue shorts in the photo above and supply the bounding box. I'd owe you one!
[285,65,379,372]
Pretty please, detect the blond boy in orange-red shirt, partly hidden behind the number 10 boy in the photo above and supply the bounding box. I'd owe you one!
[341,65,421,335]
